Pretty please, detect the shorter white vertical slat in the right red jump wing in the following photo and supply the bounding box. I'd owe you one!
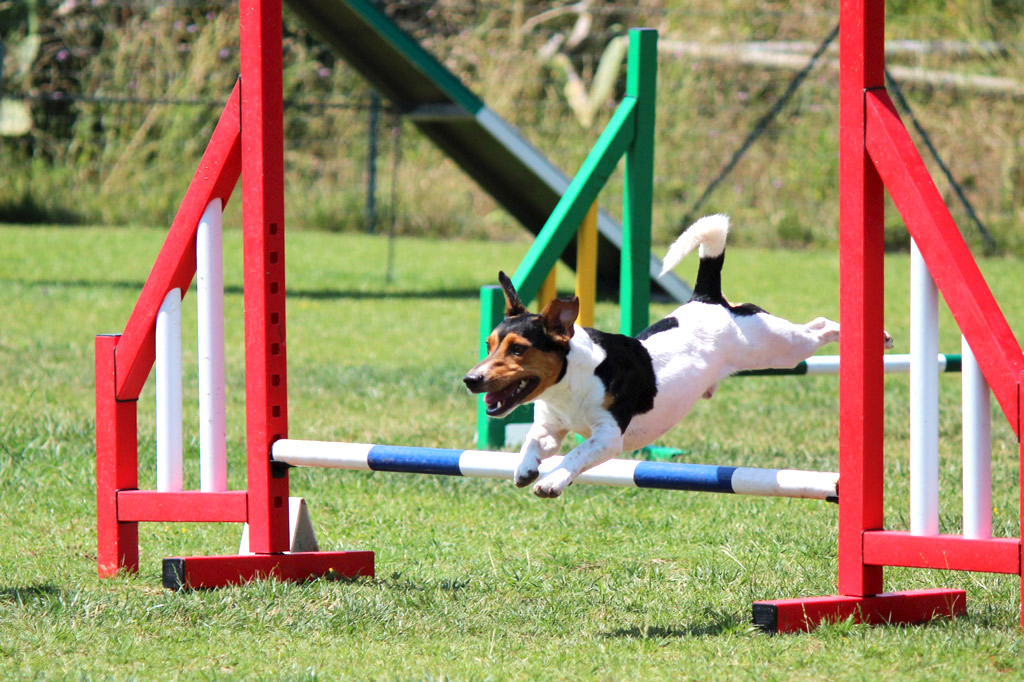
[961,339,992,538]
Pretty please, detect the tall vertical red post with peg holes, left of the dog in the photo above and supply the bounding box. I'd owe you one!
[240,0,288,552]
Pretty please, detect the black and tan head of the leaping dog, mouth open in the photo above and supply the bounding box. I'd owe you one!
[463,272,580,417]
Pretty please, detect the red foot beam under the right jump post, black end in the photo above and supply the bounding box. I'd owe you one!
[753,589,967,635]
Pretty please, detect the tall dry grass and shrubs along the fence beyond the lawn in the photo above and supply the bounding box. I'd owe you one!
[0,0,1024,251]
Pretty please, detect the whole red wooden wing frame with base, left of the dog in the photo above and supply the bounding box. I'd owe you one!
[96,0,374,589]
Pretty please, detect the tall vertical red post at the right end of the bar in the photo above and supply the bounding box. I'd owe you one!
[839,0,885,596]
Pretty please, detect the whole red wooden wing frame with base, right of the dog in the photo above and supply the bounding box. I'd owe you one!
[754,0,1024,632]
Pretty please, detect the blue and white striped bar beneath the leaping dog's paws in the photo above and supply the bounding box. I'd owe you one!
[272,439,839,502]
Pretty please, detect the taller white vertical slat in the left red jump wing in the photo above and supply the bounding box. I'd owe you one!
[196,199,227,493]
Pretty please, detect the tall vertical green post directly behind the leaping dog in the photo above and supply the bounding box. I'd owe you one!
[618,29,657,336]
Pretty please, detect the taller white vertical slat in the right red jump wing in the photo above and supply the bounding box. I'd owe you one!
[910,241,939,536]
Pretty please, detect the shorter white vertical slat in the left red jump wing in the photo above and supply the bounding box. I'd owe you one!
[156,289,183,493]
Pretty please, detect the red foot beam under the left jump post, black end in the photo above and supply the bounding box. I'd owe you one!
[163,551,374,590]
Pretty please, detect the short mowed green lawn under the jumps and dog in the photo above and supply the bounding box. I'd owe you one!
[6,227,1024,680]
